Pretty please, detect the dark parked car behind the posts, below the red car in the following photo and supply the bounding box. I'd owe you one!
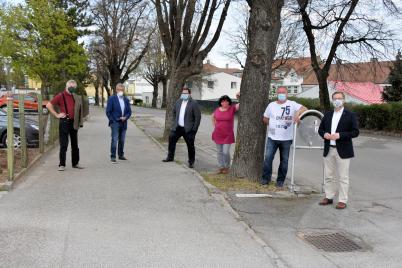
[0,109,39,148]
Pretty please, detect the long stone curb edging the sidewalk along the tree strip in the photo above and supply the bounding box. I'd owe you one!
[131,120,288,268]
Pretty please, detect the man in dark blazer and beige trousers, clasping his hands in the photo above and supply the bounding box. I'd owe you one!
[318,92,359,209]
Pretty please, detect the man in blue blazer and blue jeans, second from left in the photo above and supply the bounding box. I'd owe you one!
[106,83,131,164]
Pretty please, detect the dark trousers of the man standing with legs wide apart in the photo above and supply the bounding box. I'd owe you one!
[168,126,196,164]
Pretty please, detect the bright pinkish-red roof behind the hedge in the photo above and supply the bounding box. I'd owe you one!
[329,81,383,104]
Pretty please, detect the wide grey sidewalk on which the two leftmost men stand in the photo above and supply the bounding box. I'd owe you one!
[0,108,276,267]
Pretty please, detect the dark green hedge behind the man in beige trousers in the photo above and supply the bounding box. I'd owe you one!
[290,97,402,132]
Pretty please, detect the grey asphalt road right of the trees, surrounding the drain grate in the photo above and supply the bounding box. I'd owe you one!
[134,107,402,267]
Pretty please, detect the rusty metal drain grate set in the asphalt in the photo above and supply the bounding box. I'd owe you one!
[298,232,363,252]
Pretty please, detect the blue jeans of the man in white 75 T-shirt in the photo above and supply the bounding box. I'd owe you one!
[261,138,293,186]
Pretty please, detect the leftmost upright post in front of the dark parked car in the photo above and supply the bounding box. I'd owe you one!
[7,95,14,181]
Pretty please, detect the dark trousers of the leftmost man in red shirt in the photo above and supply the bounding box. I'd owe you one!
[59,118,80,167]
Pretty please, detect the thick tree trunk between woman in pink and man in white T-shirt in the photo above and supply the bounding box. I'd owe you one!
[231,0,283,181]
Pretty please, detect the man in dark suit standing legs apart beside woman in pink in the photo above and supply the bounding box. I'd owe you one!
[163,88,201,168]
